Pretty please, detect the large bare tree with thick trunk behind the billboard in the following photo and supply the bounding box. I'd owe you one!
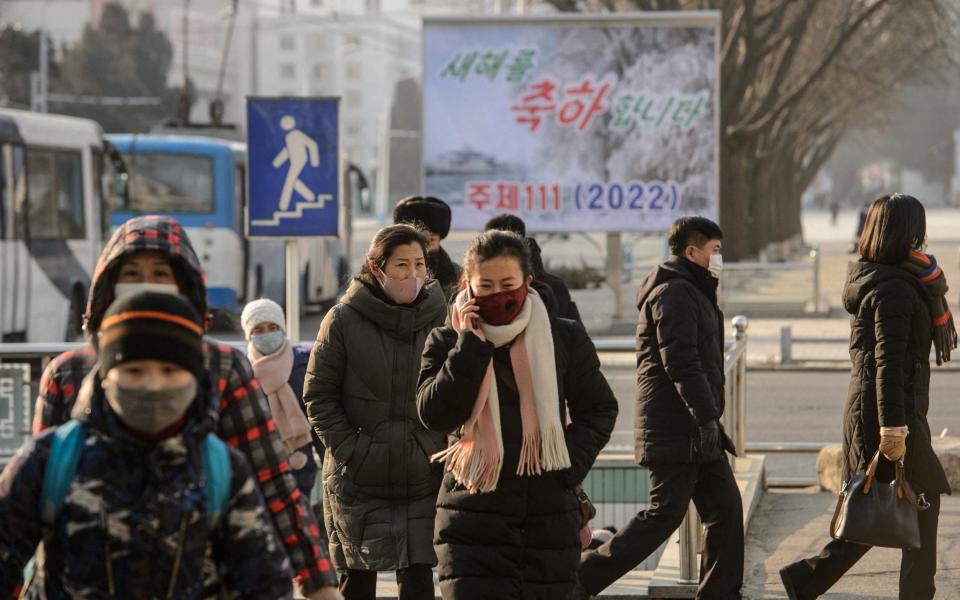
[544,0,957,258]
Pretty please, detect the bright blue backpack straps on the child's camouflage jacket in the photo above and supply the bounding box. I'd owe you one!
[23,420,233,587]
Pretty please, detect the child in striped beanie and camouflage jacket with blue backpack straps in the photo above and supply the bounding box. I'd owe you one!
[0,291,293,600]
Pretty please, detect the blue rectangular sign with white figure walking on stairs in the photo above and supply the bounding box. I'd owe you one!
[246,98,341,238]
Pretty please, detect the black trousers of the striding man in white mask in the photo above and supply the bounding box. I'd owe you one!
[577,459,743,600]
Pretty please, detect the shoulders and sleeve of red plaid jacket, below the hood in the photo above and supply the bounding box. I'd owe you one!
[33,338,337,593]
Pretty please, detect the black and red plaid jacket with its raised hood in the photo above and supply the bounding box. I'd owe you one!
[33,216,338,598]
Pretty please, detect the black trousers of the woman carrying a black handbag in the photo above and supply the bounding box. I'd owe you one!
[788,494,940,600]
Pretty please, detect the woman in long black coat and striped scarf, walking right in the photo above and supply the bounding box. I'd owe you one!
[780,194,957,600]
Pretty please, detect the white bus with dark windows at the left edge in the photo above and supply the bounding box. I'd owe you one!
[0,109,126,342]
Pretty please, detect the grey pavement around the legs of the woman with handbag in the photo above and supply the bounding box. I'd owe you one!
[743,489,960,600]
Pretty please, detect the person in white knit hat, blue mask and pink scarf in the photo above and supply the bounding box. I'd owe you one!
[240,298,323,498]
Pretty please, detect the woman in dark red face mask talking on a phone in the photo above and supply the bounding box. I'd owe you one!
[417,231,617,600]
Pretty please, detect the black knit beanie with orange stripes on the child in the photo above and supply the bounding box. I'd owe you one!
[97,291,206,381]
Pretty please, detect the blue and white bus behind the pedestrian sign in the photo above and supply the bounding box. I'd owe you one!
[107,134,347,326]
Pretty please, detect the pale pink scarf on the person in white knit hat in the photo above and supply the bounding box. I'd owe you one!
[247,340,311,454]
